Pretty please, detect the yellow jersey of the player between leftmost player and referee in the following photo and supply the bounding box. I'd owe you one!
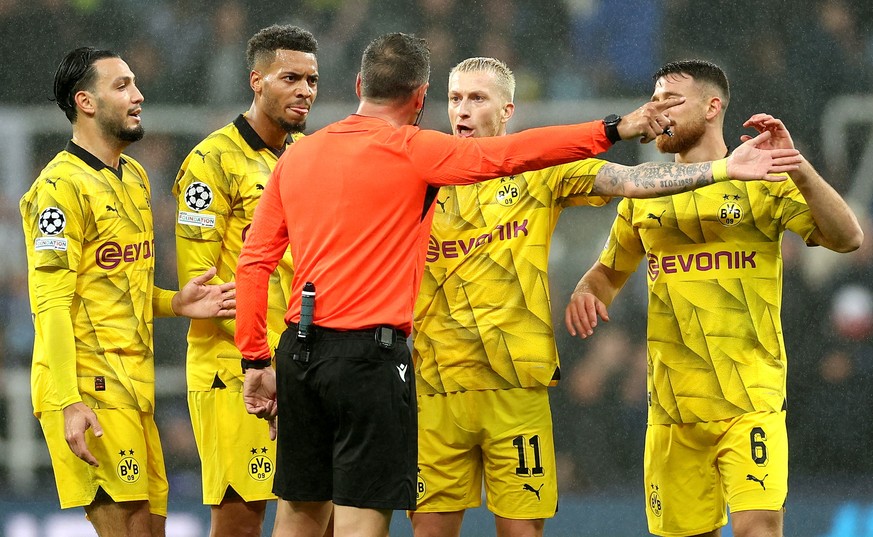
[173,115,303,391]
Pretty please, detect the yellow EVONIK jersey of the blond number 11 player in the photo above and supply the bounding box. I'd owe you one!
[415,159,609,394]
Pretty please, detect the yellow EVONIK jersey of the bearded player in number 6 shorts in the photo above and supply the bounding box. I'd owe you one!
[600,179,815,424]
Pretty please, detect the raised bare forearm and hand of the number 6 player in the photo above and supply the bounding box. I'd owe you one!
[742,114,864,252]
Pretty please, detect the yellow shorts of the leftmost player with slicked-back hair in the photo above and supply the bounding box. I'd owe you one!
[39,408,168,516]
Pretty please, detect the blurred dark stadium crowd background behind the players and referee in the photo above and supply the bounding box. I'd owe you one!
[0,0,873,537]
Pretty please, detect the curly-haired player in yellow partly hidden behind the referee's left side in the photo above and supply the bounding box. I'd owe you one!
[173,25,318,537]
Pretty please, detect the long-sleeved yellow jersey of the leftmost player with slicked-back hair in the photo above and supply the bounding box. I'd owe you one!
[20,142,155,413]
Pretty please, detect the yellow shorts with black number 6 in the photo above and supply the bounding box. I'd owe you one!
[645,412,788,537]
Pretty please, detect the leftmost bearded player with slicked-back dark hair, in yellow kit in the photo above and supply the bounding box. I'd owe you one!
[21,47,235,537]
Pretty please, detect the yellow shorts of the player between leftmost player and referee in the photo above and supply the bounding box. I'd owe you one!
[188,388,276,505]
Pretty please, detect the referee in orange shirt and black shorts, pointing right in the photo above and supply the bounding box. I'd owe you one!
[236,33,796,536]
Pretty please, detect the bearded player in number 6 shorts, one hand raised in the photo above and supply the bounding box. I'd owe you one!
[565,60,863,537]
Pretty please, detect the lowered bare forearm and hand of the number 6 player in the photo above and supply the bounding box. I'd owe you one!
[564,261,631,339]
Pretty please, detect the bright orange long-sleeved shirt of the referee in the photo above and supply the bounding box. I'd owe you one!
[236,115,611,359]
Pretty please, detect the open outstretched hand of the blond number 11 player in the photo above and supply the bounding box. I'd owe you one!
[727,130,803,181]
